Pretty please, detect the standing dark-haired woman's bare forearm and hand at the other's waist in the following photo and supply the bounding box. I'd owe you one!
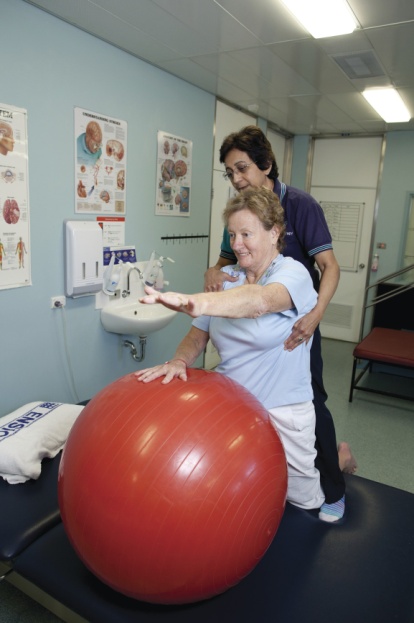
[285,249,340,350]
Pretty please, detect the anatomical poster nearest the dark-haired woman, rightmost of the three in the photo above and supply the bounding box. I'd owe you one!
[155,132,193,216]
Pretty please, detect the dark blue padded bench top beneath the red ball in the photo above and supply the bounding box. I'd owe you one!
[0,474,414,623]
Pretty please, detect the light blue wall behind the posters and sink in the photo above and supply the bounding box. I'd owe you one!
[0,0,215,416]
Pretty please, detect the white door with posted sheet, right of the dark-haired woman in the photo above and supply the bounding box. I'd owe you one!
[310,137,383,342]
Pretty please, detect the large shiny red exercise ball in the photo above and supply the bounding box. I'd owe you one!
[59,369,287,604]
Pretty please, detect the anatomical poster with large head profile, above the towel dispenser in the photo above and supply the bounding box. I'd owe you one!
[75,108,127,215]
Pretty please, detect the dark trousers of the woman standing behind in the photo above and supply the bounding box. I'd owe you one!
[311,327,345,504]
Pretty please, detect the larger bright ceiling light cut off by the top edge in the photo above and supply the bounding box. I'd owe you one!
[282,0,358,39]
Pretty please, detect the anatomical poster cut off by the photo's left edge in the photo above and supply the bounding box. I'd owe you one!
[0,104,32,290]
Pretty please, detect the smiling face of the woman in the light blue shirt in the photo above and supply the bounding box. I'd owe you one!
[228,209,279,272]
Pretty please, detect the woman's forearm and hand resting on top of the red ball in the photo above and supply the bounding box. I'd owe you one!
[135,327,208,385]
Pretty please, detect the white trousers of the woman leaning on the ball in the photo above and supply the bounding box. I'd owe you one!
[269,401,325,509]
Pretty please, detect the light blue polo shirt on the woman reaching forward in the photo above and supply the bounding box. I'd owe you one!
[193,255,317,409]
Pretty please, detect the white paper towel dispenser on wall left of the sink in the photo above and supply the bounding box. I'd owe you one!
[65,221,103,297]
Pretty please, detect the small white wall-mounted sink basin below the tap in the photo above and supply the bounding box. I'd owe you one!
[101,300,177,337]
